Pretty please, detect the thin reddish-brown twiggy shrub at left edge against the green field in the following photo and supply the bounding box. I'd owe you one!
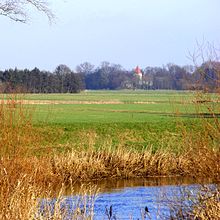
[0,94,38,157]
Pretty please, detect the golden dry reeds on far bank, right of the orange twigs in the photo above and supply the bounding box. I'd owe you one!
[51,142,220,181]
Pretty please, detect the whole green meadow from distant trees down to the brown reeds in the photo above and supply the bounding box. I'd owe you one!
[16,90,217,153]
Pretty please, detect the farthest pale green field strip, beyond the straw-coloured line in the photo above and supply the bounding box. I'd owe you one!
[22,90,201,103]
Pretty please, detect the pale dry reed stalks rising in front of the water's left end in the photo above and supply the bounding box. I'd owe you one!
[35,185,97,220]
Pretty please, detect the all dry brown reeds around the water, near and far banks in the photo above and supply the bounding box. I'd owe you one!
[0,145,220,219]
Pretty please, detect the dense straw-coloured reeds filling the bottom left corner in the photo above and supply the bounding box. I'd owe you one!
[0,170,41,219]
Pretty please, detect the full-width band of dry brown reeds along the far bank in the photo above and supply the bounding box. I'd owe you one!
[0,141,220,187]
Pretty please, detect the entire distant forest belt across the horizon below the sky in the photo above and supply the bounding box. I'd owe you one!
[0,62,220,93]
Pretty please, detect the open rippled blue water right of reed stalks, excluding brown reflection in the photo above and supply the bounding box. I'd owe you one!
[87,185,199,220]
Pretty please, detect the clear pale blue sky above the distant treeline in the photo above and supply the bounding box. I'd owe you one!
[0,0,220,71]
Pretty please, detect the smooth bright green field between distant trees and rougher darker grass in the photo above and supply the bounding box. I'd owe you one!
[25,90,219,124]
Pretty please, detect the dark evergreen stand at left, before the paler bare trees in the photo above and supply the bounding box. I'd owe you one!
[0,65,85,93]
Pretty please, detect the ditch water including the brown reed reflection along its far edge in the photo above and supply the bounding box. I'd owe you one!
[40,178,213,220]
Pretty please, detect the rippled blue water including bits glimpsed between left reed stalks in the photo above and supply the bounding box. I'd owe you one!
[41,179,213,220]
